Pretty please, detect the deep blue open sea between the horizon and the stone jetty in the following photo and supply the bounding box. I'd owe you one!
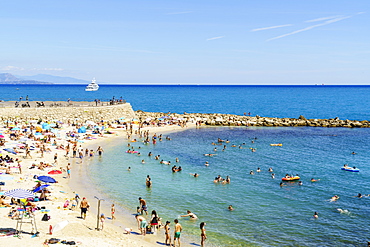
[0,85,370,120]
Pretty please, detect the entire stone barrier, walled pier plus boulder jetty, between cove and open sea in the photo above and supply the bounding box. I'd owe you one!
[0,101,370,128]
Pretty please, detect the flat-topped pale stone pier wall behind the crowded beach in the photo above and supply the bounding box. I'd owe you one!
[0,102,135,122]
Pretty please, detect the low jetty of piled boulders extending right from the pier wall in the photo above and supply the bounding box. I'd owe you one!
[135,111,370,128]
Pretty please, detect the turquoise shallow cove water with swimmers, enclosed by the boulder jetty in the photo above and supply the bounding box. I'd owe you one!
[89,127,370,246]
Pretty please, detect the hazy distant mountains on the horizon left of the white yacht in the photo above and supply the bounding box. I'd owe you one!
[0,73,90,84]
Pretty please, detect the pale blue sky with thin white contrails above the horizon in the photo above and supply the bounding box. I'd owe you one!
[0,0,370,85]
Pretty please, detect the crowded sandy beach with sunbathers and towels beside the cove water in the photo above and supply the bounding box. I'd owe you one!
[0,111,194,246]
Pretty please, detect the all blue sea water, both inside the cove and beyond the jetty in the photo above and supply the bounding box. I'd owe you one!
[0,85,370,246]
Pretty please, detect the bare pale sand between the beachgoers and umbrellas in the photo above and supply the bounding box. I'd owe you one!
[0,117,194,247]
